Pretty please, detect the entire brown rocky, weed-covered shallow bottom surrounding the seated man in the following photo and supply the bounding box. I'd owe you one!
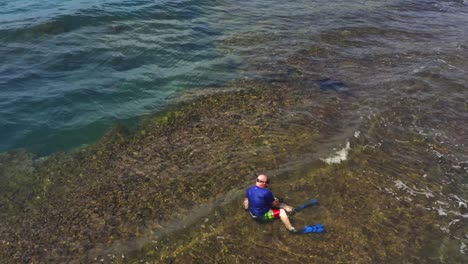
[0,72,468,263]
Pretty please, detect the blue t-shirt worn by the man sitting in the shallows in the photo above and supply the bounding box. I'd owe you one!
[246,185,275,217]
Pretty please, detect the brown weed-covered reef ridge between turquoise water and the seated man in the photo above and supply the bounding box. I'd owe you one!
[0,77,339,262]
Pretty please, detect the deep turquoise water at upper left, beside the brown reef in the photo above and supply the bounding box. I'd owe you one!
[0,1,243,153]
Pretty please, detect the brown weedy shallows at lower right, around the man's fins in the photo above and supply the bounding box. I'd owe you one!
[126,97,468,263]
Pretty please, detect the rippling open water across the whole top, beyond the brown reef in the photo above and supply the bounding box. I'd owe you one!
[0,0,468,157]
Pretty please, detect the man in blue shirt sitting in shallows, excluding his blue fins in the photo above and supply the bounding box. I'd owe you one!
[244,175,297,232]
